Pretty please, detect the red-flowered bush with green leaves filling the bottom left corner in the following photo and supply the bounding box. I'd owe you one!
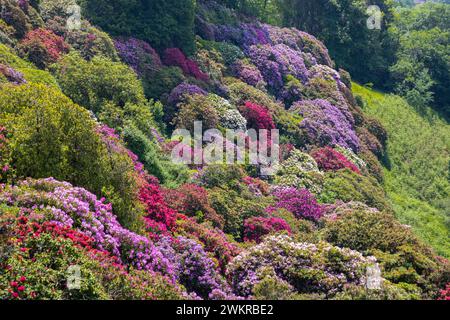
[0,211,183,300]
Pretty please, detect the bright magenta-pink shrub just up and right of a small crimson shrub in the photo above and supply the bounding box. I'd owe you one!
[268,187,323,221]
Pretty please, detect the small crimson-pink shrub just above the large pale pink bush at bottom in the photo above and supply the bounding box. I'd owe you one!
[243,217,292,243]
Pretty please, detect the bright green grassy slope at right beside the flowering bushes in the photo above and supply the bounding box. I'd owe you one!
[353,84,450,258]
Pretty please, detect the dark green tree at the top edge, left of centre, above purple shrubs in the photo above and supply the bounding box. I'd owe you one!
[80,0,195,54]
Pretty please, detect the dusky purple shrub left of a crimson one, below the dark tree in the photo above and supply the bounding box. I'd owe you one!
[114,38,162,79]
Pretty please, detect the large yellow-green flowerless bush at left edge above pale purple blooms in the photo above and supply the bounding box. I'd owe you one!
[0,84,141,228]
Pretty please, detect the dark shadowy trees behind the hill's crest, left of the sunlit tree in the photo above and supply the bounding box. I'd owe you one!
[277,0,392,85]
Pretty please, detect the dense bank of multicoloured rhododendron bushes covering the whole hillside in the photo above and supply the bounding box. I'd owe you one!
[0,0,450,300]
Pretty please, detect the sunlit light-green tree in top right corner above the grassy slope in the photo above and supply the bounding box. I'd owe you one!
[390,2,450,116]
